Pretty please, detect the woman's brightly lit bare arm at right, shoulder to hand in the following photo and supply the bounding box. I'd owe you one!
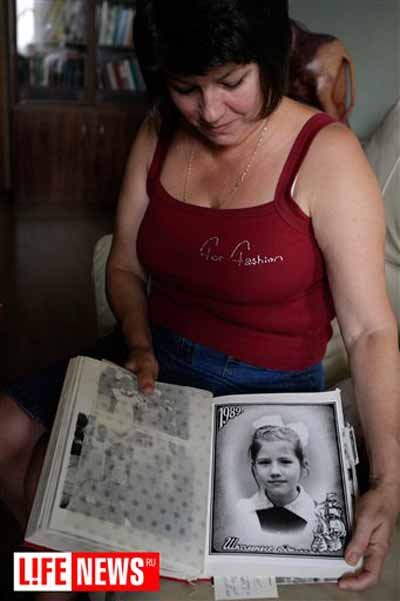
[296,125,400,590]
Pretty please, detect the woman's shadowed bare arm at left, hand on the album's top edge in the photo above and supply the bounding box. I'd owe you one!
[107,120,158,392]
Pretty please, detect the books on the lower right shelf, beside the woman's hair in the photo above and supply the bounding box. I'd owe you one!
[98,58,146,93]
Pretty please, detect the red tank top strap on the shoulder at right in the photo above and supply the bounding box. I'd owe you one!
[275,113,335,198]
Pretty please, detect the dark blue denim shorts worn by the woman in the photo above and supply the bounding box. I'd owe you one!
[3,325,324,429]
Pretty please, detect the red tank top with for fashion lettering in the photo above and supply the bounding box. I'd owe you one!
[137,113,334,370]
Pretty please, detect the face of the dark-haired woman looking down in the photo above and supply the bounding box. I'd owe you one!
[167,63,264,146]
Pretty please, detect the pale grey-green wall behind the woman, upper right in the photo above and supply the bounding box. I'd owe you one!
[289,0,400,139]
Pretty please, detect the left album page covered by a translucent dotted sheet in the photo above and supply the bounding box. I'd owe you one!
[28,358,212,578]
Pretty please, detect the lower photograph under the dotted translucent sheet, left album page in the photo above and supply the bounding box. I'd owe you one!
[60,412,195,540]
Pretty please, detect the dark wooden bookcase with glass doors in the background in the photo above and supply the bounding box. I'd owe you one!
[8,0,146,207]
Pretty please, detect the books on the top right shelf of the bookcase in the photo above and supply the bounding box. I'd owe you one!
[97,0,135,47]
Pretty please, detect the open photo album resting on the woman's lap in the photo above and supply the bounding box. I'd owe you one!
[25,357,358,581]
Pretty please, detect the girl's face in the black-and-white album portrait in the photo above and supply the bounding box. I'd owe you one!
[253,440,302,505]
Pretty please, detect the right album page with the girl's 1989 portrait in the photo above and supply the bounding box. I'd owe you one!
[206,391,353,578]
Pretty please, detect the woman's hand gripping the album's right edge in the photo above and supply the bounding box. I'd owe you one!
[339,482,400,591]
